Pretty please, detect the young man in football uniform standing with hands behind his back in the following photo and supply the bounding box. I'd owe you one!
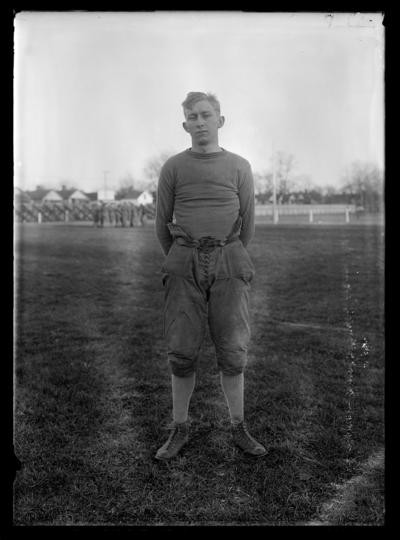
[156,92,266,460]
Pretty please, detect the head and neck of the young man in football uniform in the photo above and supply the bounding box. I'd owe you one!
[182,92,225,151]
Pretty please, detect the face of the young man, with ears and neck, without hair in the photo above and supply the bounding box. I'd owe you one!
[183,100,224,146]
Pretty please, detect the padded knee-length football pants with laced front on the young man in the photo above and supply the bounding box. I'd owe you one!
[162,238,254,377]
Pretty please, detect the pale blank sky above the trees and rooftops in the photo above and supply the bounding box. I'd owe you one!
[14,11,384,191]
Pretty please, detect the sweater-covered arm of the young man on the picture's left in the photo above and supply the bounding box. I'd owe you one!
[156,165,174,255]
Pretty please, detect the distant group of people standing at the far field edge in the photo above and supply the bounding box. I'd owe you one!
[92,201,146,227]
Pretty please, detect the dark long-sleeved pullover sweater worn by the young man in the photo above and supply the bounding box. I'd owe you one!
[156,149,255,254]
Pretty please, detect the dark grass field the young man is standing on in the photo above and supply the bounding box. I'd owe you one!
[14,224,384,525]
